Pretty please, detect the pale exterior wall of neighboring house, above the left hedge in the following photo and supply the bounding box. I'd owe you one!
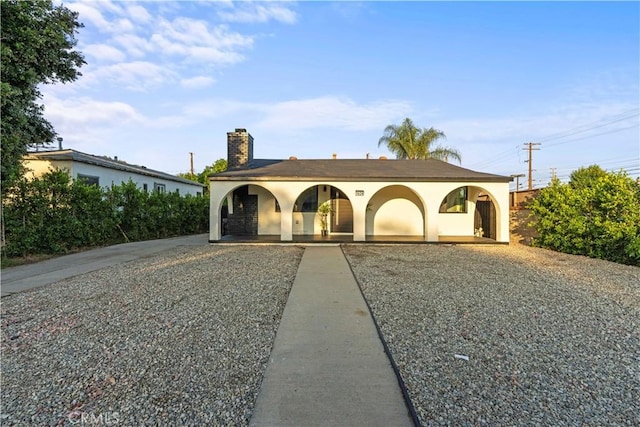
[25,160,203,196]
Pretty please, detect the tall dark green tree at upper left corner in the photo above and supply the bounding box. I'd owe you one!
[0,0,85,194]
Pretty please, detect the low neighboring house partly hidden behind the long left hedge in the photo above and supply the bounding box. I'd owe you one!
[24,150,206,196]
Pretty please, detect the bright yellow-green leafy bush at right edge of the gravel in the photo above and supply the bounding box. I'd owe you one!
[529,166,640,265]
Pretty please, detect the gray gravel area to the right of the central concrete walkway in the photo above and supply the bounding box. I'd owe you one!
[344,245,640,426]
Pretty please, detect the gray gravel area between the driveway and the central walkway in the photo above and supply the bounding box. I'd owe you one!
[0,246,303,426]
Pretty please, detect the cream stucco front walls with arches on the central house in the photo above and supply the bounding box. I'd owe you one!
[209,180,509,242]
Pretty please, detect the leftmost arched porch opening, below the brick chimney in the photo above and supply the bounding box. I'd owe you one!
[219,184,280,236]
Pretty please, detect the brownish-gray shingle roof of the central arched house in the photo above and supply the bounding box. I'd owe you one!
[209,159,511,182]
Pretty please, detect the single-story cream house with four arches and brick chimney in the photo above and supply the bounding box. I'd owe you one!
[209,129,511,243]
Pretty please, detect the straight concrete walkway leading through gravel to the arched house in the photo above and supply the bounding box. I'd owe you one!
[250,246,413,426]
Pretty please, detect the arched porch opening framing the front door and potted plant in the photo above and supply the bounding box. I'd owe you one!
[291,184,353,236]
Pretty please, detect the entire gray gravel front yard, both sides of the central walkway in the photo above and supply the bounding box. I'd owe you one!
[0,244,640,426]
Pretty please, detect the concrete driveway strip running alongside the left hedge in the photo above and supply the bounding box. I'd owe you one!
[0,234,209,297]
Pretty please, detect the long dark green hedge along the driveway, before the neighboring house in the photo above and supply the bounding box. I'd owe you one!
[2,170,209,257]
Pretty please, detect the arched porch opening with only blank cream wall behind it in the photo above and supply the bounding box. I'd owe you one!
[365,185,425,238]
